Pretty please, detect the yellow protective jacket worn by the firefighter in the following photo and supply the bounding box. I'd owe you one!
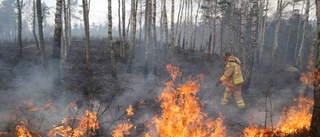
[220,55,244,84]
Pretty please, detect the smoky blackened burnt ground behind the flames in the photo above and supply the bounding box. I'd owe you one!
[0,40,312,136]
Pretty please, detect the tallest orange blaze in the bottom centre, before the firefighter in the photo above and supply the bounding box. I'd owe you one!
[146,65,226,137]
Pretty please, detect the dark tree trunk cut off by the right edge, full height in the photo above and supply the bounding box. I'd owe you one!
[310,0,320,137]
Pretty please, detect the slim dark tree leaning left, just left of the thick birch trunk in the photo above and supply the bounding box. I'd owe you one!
[36,0,46,70]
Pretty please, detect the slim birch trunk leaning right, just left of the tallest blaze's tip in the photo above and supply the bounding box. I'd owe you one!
[127,0,137,73]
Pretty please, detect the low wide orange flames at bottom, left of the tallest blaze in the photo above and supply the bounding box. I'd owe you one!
[47,110,99,137]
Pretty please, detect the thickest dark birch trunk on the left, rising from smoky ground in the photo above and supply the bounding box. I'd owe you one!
[52,0,62,85]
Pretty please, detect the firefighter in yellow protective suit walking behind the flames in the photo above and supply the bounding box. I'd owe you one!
[216,52,245,110]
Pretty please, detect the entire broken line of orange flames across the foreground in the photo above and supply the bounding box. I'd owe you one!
[0,65,314,137]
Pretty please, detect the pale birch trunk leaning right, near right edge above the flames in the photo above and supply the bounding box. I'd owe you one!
[295,0,310,69]
